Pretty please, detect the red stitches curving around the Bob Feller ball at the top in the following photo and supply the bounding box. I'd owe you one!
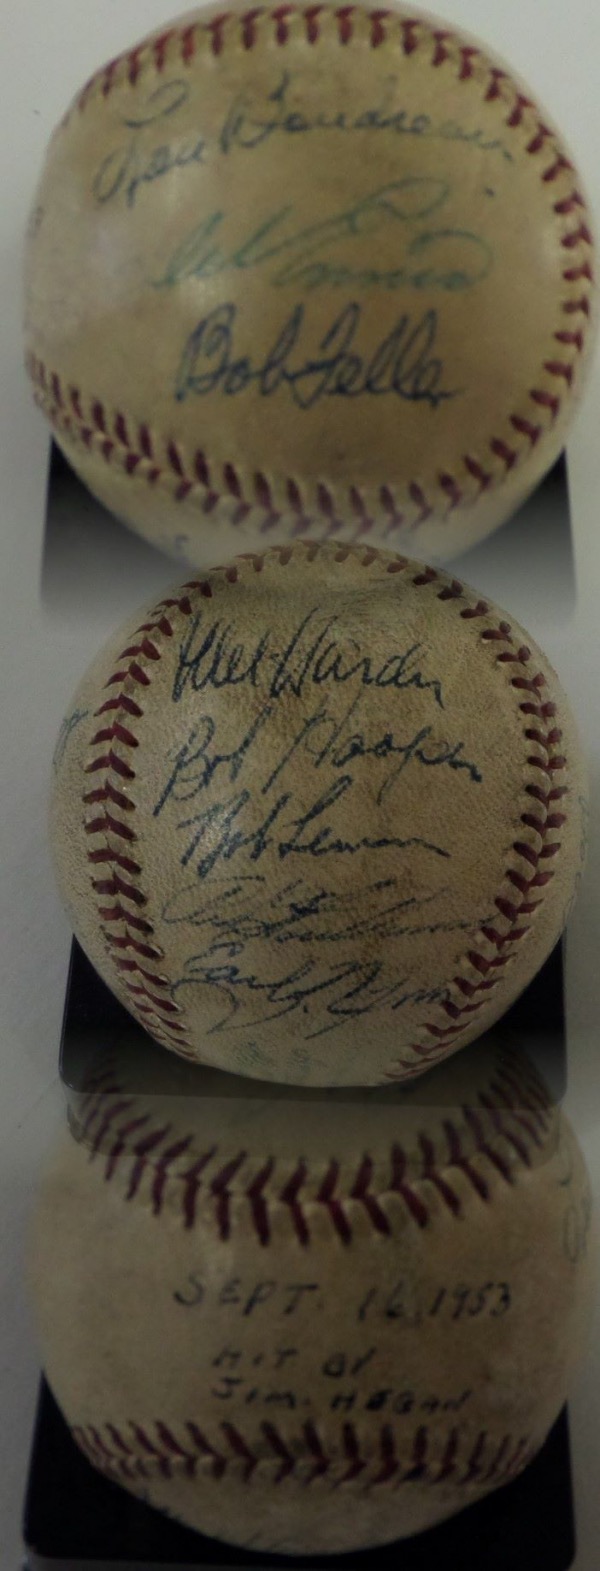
[41,5,594,537]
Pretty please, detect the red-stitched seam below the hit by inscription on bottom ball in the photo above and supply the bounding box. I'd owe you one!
[72,1420,537,1488]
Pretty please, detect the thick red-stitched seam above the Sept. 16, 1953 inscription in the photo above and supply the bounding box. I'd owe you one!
[77,1060,553,1247]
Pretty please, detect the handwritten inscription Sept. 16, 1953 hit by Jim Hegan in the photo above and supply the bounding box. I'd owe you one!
[173,1271,512,1422]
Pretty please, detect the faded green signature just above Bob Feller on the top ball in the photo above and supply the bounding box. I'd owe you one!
[154,174,493,294]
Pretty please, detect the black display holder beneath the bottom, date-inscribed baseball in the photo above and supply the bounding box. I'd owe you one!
[25,1382,575,1571]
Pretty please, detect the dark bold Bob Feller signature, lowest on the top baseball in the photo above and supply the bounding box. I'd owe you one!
[174,302,462,410]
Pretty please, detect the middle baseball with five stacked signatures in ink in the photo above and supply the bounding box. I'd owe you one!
[52,544,586,1086]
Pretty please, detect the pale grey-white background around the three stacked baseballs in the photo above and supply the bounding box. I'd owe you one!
[0,0,600,1571]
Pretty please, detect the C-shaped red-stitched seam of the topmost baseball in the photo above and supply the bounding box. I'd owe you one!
[27,5,594,540]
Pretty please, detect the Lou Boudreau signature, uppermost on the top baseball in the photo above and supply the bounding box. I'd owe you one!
[93,71,514,209]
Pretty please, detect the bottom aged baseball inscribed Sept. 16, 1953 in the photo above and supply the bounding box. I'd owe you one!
[33,1027,595,1554]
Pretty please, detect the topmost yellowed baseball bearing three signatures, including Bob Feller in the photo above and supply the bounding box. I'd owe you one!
[25,5,595,567]
